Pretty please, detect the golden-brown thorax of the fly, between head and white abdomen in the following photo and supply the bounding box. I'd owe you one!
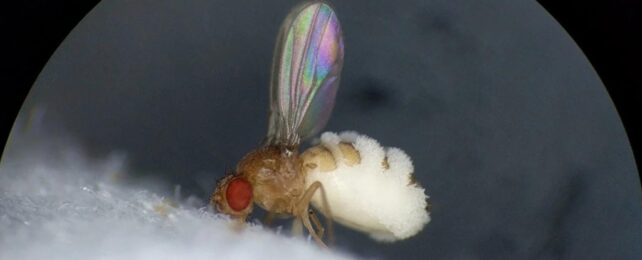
[237,146,305,214]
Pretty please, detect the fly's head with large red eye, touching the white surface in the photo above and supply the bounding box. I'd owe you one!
[210,174,253,219]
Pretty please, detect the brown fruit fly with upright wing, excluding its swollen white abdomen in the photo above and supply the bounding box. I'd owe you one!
[210,1,343,246]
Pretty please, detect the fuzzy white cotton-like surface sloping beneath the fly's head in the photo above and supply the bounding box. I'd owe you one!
[0,137,348,259]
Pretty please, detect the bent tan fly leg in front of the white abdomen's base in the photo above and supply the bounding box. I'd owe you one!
[295,181,332,248]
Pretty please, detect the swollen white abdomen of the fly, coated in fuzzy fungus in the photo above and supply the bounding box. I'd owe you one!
[306,132,430,242]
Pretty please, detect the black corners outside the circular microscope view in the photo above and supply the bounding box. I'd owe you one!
[0,0,642,179]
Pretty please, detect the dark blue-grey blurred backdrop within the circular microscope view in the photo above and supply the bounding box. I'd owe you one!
[0,0,642,259]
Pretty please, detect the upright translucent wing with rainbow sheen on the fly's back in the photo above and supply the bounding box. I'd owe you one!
[267,1,343,146]
